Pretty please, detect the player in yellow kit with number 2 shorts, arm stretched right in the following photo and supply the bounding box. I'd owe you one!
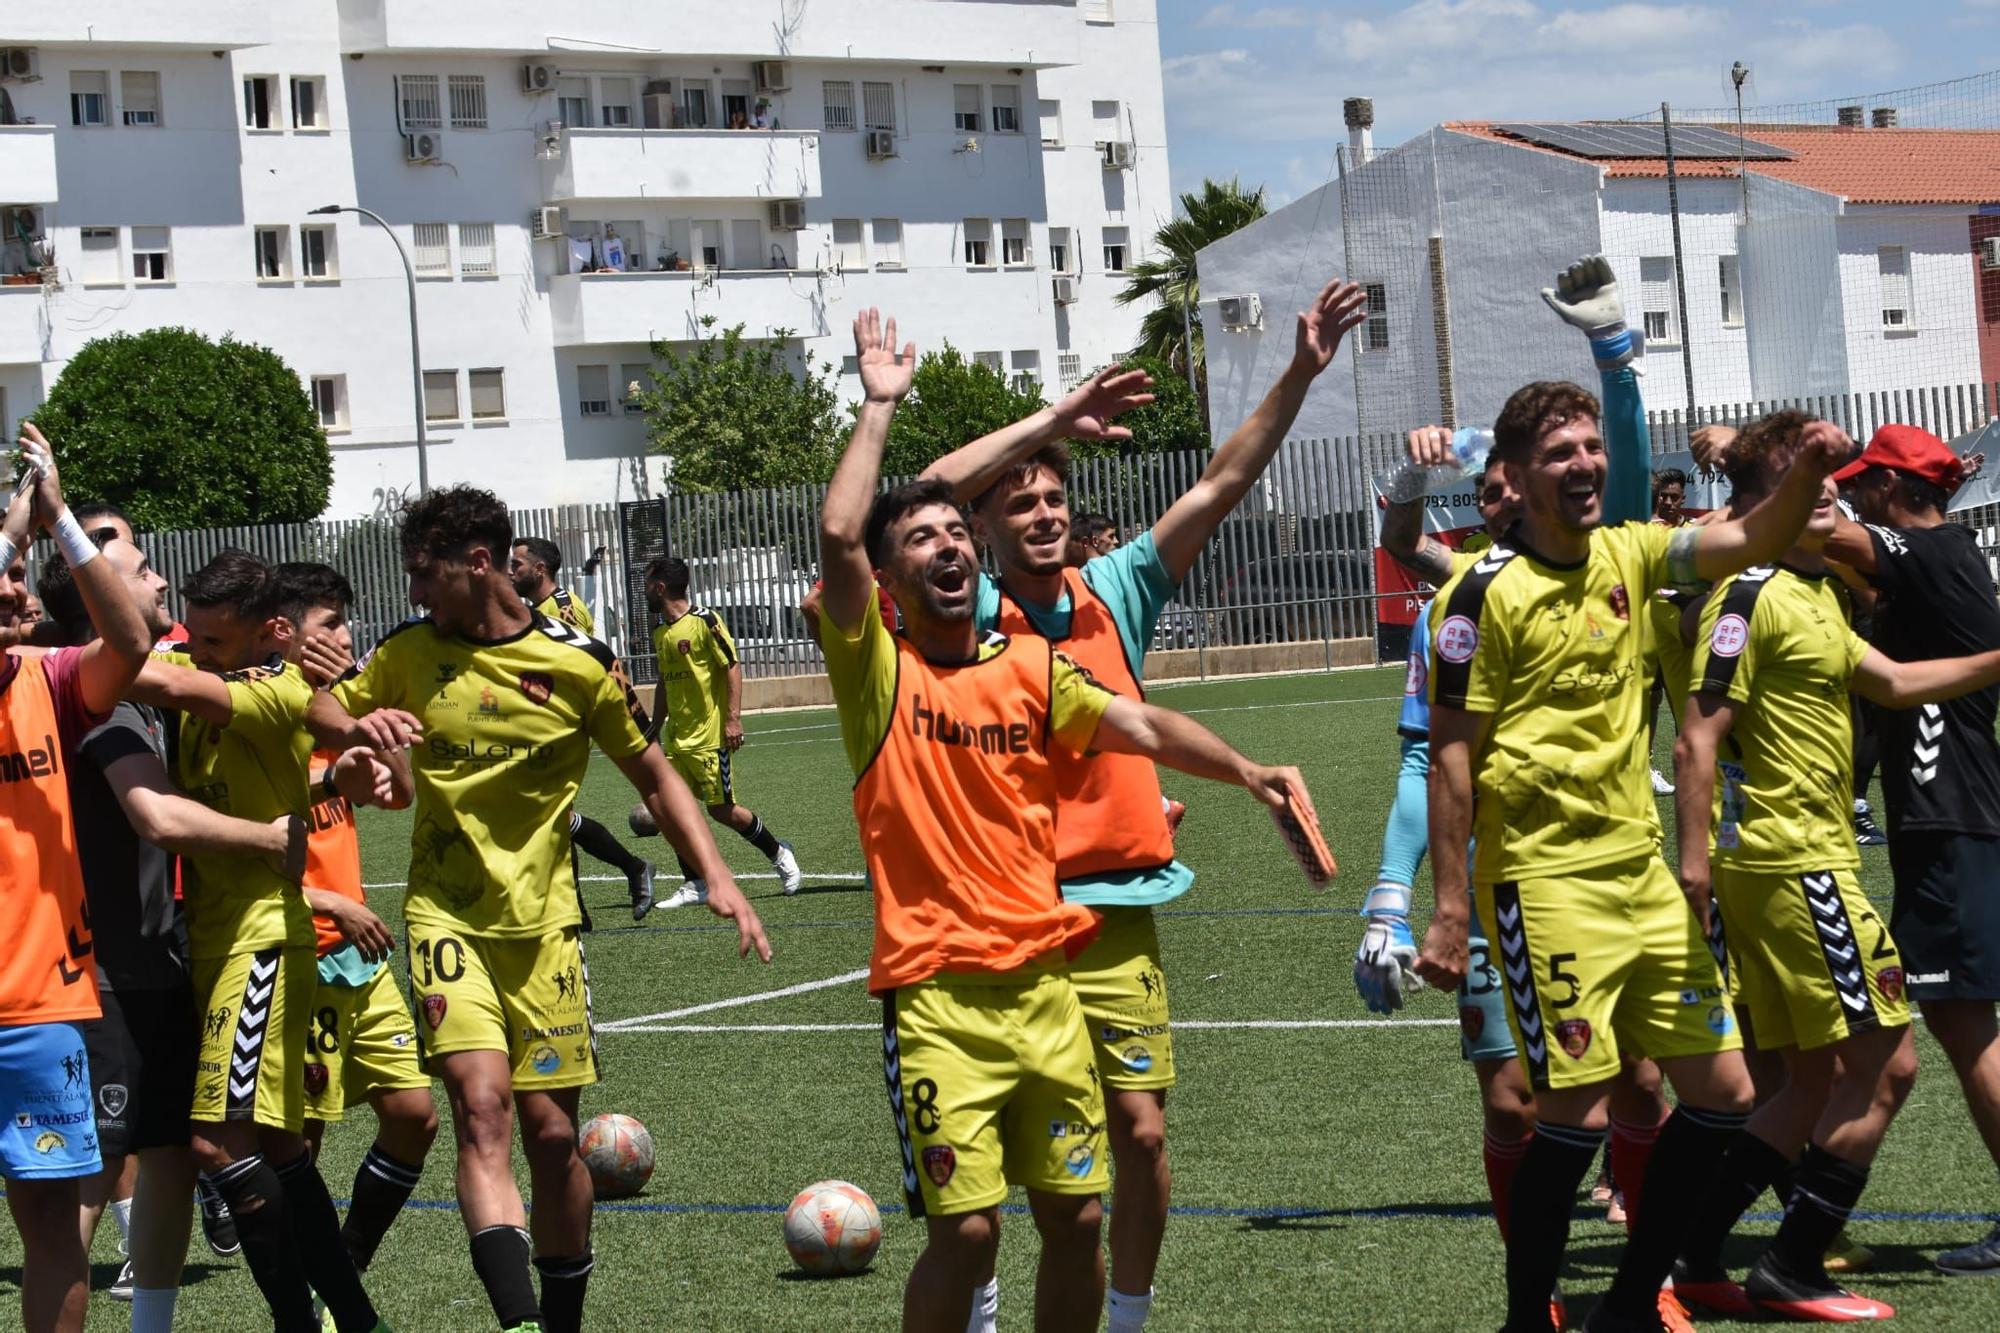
[1674,410,2000,1319]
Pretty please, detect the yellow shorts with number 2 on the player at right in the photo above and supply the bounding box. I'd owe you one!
[1716,867,1910,1051]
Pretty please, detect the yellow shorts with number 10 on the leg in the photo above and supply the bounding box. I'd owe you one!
[406,921,598,1089]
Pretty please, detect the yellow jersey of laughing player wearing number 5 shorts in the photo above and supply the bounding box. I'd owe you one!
[1430,522,1672,885]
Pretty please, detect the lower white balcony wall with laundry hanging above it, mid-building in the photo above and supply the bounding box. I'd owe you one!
[548,268,826,346]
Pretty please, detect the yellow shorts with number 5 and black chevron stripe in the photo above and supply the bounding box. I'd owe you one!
[1476,853,1742,1089]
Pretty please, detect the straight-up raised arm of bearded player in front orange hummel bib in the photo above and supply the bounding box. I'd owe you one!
[816,308,916,632]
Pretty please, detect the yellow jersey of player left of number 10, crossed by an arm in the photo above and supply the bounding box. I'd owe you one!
[160,652,314,959]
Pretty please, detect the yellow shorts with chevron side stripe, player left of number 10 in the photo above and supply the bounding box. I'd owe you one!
[188,945,320,1133]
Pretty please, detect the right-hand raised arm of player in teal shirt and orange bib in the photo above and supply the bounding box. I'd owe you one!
[1152,278,1368,582]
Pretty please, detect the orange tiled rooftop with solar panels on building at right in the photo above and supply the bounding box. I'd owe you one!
[1444,120,2000,204]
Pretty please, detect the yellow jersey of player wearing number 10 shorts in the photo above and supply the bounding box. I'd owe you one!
[334,614,648,939]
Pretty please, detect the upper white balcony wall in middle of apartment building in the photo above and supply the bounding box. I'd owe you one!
[548,128,820,202]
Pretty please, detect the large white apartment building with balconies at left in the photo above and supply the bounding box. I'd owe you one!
[0,0,1172,516]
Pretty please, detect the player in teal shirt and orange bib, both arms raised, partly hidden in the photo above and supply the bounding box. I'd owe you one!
[924,280,1366,1333]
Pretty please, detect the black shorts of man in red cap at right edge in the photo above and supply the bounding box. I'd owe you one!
[1888,829,2000,1001]
